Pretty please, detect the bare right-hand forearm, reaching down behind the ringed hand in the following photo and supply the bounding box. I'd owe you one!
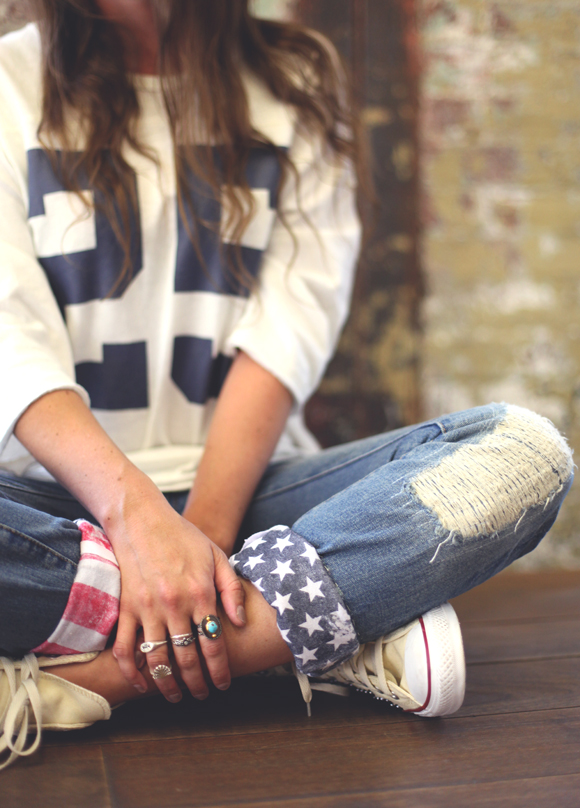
[183,352,292,555]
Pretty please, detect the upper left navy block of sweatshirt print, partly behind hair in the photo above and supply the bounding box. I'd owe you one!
[27,149,142,311]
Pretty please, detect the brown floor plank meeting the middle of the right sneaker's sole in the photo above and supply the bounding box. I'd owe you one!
[462,616,580,664]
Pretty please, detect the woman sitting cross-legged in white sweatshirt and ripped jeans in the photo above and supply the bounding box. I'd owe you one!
[0,0,572,765]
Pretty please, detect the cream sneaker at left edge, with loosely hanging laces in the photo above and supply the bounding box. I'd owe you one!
[0,652,111,769]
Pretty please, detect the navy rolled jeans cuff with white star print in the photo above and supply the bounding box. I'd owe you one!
[230,525,359,676]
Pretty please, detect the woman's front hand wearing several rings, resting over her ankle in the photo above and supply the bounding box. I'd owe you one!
[106,497,245,702]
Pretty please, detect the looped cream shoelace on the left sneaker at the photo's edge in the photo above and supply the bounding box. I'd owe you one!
[0,654,42,769]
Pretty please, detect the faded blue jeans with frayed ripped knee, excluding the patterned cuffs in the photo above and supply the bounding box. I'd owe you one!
[0,404,573,655]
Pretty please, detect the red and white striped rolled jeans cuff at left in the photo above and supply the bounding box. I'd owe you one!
[32,519,121,654]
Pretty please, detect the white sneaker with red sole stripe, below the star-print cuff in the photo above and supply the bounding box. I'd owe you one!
[296,603,465,717]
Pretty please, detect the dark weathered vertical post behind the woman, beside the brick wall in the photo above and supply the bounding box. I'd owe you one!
[297,0,423,446]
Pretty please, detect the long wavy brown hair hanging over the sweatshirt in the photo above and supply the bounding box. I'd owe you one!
[31,0,362,288]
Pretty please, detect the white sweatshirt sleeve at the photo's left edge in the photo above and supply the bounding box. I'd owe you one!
[0,146,89,452]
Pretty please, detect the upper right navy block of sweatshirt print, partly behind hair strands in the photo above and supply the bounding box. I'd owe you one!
[175,148,281,297]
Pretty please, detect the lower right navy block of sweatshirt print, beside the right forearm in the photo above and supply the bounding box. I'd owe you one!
[171,337,232,404]
